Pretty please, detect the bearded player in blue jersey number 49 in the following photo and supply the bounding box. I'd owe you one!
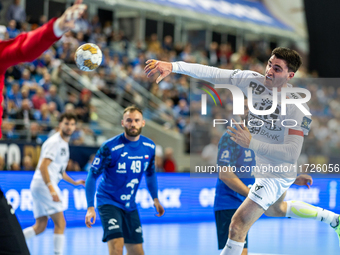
[85,106,164,255]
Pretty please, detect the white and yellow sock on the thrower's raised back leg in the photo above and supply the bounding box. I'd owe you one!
[286,201,339,228]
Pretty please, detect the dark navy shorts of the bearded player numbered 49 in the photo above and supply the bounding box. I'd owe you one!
[98,205,143,244]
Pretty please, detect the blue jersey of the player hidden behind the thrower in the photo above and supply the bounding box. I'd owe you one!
[214,133,256,211]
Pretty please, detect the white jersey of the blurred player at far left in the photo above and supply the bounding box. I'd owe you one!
[33,132,70,185]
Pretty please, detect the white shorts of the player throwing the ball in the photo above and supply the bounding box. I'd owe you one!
[248,178,295,211]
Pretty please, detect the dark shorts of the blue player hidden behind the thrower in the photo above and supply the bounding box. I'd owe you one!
[215,209,248,250]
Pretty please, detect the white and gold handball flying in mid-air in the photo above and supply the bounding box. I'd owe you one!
[74,43,103,72]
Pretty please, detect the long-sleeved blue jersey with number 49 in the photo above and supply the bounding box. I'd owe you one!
[86,133,157,211]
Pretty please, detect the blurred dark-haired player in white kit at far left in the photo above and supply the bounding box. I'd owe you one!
[23,113,85,255]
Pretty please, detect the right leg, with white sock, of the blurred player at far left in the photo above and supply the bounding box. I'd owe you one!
[50,212,66,255]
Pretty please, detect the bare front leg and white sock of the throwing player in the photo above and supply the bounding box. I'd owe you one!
[220,197,264,255]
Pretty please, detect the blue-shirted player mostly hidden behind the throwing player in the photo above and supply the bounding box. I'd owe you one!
[214,102,312,255]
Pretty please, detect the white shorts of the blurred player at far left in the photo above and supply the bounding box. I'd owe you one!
[30,180,64,219]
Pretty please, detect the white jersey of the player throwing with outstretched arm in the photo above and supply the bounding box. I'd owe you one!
[172,62,311,177]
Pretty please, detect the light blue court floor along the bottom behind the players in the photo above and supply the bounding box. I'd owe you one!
[28,218,340,255]
